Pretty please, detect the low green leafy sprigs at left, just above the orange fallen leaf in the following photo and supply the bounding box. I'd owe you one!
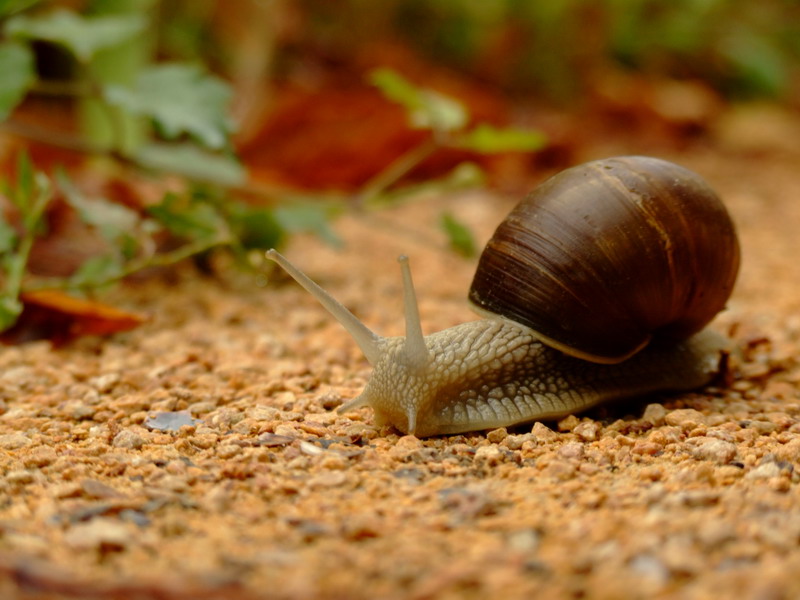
[0,153,338,331]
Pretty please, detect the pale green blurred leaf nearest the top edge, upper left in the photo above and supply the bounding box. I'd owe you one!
[5,10,146,63]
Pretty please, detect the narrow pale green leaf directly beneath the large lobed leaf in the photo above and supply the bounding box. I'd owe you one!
[134,143,247,187]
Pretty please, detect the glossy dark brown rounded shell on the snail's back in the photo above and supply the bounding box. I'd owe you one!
[469,156,739,363]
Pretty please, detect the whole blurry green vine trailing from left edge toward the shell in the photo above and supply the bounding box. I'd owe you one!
[0,0,546,331]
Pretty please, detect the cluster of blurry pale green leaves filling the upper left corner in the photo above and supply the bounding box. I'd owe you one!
[0,0,245,180]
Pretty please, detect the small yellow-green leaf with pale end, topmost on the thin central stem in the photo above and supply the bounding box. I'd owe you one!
[370,69,469,131]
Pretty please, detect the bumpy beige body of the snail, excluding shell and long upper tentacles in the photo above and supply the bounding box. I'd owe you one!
[345,319,729,437]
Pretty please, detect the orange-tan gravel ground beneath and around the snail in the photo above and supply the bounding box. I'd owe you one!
[0,149,800,599]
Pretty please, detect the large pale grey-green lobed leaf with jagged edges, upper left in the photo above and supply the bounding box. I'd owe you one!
[105,63,233,149]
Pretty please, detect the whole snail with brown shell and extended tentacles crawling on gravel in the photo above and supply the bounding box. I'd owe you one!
[267,156,739,437]
